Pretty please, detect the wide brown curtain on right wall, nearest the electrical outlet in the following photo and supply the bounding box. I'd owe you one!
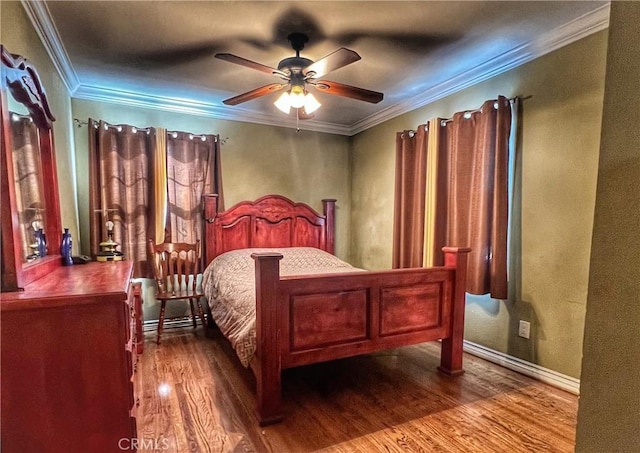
[436,96,511,299]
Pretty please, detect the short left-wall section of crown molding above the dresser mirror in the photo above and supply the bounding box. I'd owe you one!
[21,0,80,96]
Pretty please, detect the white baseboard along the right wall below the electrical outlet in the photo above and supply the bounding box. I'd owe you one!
[463,340,580,395]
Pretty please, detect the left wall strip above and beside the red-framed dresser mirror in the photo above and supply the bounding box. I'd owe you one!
[0,1,79,244]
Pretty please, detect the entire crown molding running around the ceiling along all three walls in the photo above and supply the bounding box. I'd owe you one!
[21,0,610,136]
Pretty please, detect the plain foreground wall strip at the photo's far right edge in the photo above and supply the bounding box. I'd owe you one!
[576,2,640,453]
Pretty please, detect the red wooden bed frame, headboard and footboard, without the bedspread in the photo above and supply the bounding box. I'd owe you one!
[204,195,470,425]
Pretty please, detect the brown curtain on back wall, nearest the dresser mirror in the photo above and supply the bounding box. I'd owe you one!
[89,119,155,277]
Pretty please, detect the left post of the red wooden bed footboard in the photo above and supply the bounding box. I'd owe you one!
[251,253,282,426]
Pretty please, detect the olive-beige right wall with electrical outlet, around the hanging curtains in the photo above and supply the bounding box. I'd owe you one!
[351,32,607,377]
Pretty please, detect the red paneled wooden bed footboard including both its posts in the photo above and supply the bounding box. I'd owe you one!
[252,247,470,425]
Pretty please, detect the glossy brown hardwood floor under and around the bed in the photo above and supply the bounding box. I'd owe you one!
[138,326,578,453]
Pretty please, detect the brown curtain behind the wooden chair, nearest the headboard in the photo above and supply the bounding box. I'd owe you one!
[166,132,224,243]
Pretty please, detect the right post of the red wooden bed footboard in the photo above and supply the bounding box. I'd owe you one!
[438,247,471,376]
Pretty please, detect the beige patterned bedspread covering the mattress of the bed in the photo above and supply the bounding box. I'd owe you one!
[202,247,362,367]
